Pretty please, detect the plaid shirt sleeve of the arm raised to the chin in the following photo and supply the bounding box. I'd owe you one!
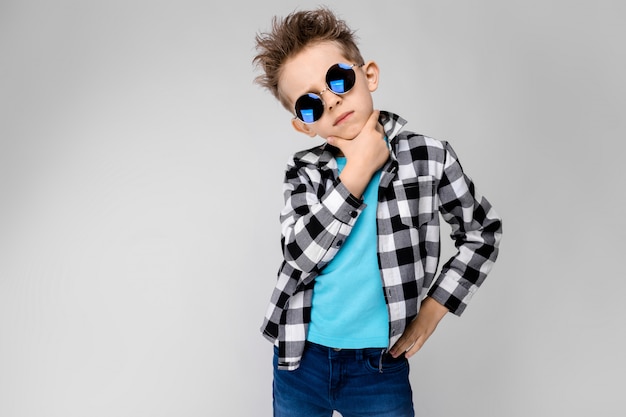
[280,158,365,283]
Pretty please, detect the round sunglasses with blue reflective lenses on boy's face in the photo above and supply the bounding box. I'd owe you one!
[294,63,364,123]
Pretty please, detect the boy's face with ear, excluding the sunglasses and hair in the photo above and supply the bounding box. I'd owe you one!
[278,42,378,139]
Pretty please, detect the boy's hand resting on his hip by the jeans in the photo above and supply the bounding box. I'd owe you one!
[389,297,448,359]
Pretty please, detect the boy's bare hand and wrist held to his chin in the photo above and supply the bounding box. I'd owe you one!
[327,110,389,198]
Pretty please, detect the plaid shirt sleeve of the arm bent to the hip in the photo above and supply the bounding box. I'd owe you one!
[429,142,502,315]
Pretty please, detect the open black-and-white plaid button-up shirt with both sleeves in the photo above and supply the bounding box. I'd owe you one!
[261,112,502,370]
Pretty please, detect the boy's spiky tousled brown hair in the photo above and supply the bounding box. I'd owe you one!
[252,7,363,109]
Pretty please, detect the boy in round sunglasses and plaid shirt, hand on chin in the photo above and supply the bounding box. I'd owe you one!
[254,8,501,417]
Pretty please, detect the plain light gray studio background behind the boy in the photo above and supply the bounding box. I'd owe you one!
[0,0,626,417]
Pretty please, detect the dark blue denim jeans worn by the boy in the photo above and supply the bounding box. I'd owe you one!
[273,342,415,417]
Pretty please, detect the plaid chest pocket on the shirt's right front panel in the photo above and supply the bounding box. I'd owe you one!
[393,175,436,228]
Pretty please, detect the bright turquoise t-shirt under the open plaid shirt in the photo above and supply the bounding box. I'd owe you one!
[307,157,389,349]
